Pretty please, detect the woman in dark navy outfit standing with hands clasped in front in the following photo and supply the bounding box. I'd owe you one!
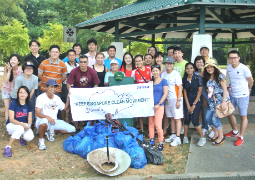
[182,62,206,146]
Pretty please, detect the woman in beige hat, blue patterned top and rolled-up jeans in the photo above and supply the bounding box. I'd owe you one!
[203,59,229,146]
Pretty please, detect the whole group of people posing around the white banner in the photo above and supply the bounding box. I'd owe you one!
[2,38,253,157]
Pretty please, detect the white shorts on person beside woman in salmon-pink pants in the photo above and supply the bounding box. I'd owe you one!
[165,97,183,119]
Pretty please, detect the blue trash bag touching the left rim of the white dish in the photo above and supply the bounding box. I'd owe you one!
[74,136,94,159]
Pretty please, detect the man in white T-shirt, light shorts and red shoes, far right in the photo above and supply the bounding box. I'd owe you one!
[225,50,254,146]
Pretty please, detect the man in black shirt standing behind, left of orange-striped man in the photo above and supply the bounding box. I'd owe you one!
[24,40,46,124]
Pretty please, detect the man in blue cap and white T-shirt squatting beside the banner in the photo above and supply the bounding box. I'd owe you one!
[36,79,75,150]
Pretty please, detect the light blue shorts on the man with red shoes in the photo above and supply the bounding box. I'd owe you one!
[230,96,249,116]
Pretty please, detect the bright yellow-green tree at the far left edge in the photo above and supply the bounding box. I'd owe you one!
[0,19,30,56]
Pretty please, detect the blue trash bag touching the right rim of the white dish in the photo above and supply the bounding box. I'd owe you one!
[128,147,147,169]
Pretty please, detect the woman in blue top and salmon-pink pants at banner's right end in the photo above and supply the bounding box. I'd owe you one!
[148,64,168,151]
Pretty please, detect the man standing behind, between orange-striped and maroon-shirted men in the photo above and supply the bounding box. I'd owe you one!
[61,49,79,122]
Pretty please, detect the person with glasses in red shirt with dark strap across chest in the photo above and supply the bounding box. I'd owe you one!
[131,54,151,134]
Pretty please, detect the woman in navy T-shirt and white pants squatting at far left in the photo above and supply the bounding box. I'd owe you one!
[4,86,34,157]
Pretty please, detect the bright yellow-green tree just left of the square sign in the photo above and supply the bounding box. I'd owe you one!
[38,23,69,52]
